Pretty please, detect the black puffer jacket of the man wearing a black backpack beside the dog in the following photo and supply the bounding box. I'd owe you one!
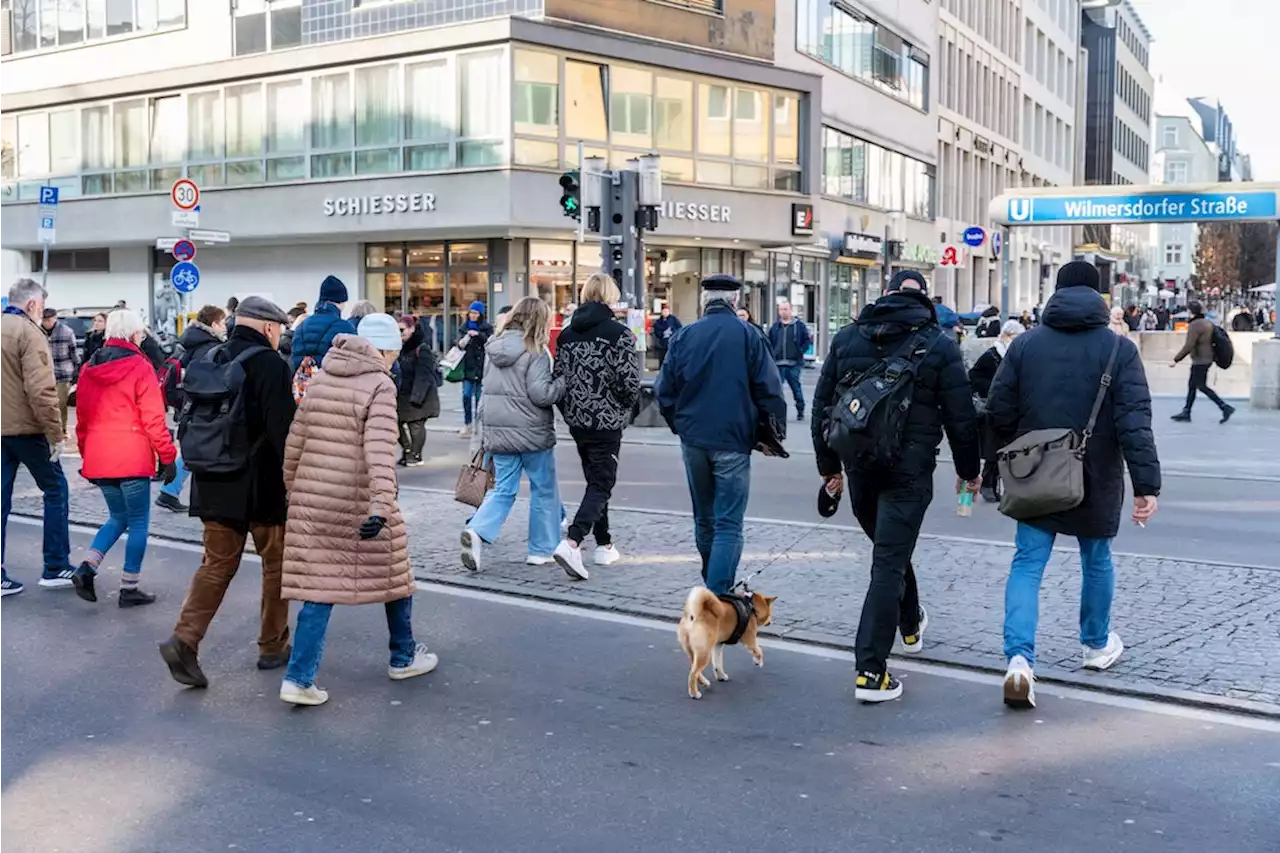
[810,291,980,480]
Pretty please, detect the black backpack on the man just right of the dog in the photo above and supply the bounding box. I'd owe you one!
[826,324,941,469]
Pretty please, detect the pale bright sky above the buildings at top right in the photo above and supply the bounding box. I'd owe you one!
[1132,0,1280,181]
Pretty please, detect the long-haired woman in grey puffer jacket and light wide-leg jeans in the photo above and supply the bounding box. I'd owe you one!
[462,296,564,571]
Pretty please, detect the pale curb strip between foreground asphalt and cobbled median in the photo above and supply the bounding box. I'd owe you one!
[22,512,1280,720]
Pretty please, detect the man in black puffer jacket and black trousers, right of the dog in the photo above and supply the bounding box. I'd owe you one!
[812,270,980,702]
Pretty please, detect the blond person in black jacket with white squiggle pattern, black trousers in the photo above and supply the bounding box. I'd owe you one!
[553,273,640,580]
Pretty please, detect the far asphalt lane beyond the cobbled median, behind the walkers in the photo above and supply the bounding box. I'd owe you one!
[401,432,1280,566]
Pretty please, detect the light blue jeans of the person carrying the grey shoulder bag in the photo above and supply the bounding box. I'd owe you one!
[1005,524,1116,666]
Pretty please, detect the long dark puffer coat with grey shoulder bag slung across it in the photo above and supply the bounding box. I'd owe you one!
[987,287,1160,539]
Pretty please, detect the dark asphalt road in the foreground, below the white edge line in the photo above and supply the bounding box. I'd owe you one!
[0,525,1280,853]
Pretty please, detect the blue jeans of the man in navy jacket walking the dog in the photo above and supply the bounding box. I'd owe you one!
[681,444,751,596]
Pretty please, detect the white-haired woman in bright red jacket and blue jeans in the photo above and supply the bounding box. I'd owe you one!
[72,310,178,607]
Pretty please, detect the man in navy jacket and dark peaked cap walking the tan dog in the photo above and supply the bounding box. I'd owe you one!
[655,275,787,596]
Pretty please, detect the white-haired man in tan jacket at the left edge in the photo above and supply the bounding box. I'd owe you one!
[0,278,72,597]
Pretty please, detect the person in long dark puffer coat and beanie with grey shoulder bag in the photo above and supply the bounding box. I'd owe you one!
[987,261,1160,707]
